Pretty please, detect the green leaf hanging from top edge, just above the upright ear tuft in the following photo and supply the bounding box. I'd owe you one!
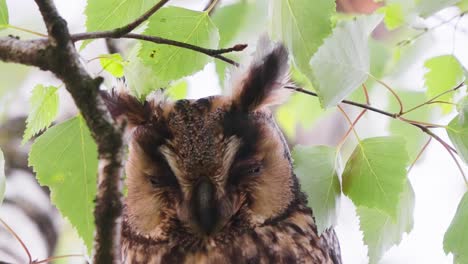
[271,0,335,80]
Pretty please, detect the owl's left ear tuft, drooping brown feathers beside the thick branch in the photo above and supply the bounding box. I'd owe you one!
[100,89,152,128]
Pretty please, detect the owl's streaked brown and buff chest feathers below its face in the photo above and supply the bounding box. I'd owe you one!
[123,207,333,264]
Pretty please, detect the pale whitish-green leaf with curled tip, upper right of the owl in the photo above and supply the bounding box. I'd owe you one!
[310,14,382,108]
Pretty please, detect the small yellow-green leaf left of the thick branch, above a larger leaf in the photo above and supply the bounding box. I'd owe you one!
[22,84,59,144]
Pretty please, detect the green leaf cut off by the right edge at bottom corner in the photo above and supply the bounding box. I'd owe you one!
[444,192,468,264]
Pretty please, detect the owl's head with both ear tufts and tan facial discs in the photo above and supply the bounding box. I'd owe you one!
[103,42,298,238]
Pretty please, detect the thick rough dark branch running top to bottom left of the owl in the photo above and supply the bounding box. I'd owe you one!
[30,0,123,263]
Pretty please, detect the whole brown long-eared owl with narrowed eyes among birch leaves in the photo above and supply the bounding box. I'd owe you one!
[103,41,341,264]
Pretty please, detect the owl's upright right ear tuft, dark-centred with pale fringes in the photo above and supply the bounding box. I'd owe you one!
[232,37,289,112]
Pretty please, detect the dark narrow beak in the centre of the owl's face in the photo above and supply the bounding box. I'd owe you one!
[192,177,219,235]
